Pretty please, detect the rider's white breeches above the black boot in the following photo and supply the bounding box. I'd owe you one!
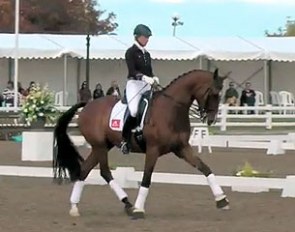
[126,80,151,117]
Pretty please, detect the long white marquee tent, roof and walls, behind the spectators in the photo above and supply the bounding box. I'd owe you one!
[0,34,295,103]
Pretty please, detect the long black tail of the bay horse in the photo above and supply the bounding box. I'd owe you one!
[52,102,86,181]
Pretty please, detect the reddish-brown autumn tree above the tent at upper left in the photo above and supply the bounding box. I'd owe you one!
[0,0,118,34]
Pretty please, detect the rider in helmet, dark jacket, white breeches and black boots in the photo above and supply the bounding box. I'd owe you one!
[121,24,159,154]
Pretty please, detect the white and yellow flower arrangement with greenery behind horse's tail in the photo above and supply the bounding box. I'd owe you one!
[22,84,57,124]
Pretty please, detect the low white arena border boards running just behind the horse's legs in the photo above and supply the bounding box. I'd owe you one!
[0,166,295,197]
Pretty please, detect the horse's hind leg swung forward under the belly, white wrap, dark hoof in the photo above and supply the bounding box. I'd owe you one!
[97,148,133,214]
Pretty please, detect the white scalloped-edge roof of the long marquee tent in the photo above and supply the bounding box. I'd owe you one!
[0,34,295,62]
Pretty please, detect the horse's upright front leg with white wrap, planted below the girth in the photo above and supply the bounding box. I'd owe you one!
[132,148,159,219]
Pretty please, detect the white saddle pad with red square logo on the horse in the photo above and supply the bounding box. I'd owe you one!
[109,101,127,131]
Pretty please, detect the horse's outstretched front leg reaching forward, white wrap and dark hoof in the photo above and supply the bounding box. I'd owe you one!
[175,145,229,209]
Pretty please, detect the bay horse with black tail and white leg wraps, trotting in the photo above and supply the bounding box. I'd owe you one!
[53,69,229,219]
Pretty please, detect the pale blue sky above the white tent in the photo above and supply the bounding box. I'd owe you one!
[97,0,295,37]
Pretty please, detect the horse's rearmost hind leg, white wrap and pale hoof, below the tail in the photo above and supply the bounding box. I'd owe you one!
[69,149,98,217]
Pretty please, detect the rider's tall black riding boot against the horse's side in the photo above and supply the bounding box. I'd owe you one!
[121,115,136,154]
